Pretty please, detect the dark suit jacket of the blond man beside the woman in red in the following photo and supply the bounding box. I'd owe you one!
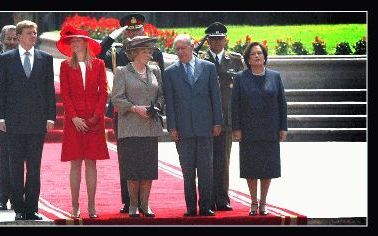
[0,48,56,134]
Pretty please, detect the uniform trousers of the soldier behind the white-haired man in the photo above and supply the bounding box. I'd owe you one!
[212,130,232,206]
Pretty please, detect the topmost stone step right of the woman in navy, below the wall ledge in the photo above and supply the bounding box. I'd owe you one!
[285,89,366,102]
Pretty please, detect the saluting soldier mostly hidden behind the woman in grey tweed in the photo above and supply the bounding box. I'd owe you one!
[99,14,164,213]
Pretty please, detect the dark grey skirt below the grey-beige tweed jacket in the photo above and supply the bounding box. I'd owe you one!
[117,137,158,180]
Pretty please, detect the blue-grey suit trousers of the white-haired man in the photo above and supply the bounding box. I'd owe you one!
[176,137,213,211]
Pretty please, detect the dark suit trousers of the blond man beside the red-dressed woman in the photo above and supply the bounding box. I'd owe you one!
[7,133,45,213]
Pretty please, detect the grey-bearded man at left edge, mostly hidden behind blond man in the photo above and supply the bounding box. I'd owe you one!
[0,25,18,210]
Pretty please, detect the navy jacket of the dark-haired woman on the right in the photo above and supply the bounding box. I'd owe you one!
[232,69,287,141]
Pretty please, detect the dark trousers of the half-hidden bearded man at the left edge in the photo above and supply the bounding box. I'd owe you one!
[0,131,11,203]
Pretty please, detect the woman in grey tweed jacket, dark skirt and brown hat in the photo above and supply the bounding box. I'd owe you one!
[111,36,163,217]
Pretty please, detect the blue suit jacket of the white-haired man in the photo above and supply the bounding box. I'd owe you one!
[163,58,223,138]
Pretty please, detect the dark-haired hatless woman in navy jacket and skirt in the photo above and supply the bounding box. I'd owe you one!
[232,42,287,216]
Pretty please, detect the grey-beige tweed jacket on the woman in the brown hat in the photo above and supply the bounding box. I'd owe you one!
[111,64,164,139]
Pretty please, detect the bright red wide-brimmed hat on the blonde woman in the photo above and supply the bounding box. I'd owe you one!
[56,25,101,57]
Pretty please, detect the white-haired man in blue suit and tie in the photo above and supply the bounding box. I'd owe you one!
[163,34,223,216]
